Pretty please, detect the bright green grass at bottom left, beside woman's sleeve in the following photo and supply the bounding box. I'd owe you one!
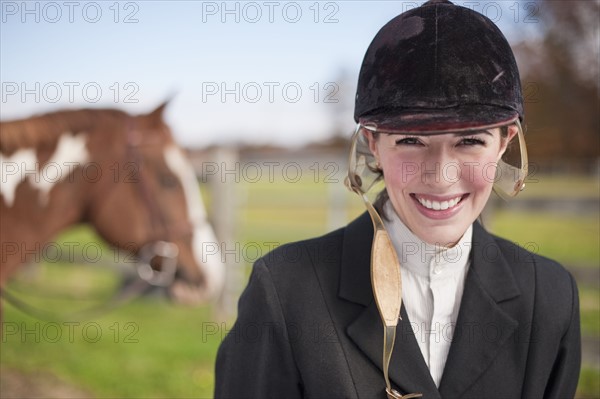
[2,299,221,398]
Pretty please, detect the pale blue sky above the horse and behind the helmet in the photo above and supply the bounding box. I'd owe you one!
[0,0,538,147]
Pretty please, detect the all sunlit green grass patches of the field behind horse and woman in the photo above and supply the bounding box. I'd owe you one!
[0,173,600,398]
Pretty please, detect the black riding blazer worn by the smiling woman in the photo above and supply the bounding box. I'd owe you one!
[215,214,581,399]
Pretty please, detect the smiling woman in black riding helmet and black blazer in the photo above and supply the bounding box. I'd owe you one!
[215,0,581,399]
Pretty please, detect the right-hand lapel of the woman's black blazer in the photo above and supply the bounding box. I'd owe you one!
[439,222,520,398]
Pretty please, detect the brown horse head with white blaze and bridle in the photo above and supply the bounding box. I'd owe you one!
[87,103,225,303]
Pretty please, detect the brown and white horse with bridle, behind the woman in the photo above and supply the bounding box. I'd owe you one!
[0,103,225,303]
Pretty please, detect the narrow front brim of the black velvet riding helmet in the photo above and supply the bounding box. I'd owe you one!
[359,104,519,134]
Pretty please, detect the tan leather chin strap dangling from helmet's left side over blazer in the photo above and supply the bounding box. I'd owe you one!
[345,125,423,399]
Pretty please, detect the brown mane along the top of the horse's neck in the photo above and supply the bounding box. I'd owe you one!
[0,109,128,155]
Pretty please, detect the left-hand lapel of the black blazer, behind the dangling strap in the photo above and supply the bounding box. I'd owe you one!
[339,217,440,398]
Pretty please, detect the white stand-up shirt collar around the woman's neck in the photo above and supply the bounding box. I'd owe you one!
[383,201,473,279]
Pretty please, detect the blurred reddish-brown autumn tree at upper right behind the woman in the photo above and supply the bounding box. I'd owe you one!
[515,0,600,170]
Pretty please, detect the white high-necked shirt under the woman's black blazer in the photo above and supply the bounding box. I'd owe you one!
[384,201,473,387]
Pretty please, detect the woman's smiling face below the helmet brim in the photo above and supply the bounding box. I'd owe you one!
[365,127,517,247]
